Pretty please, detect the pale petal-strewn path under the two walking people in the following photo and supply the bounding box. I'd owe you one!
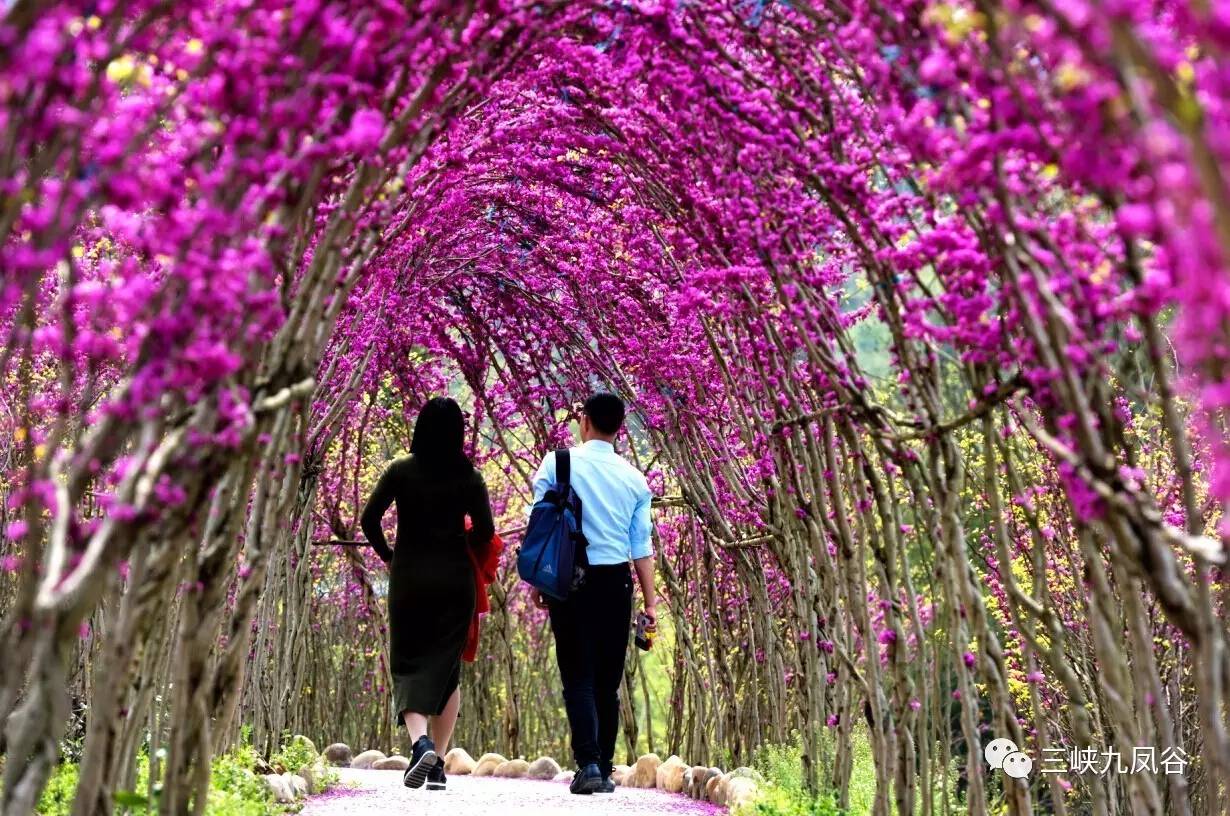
[300,768,726,816]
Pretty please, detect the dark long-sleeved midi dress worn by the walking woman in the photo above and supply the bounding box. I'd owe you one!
[360,455,494,722]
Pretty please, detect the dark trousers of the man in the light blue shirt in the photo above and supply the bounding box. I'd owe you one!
[550,564,632,777]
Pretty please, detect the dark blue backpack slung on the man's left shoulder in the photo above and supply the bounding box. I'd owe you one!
[517,450,589,601]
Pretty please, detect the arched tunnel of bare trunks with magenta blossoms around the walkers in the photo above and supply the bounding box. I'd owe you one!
[0,0,1230,816]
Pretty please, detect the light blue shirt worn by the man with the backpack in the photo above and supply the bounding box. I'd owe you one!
[534,439,653,564]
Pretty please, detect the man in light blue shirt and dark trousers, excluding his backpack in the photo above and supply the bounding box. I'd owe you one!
[534,394,657,794]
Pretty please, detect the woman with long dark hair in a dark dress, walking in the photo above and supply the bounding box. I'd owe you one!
[362,396,494,790]
